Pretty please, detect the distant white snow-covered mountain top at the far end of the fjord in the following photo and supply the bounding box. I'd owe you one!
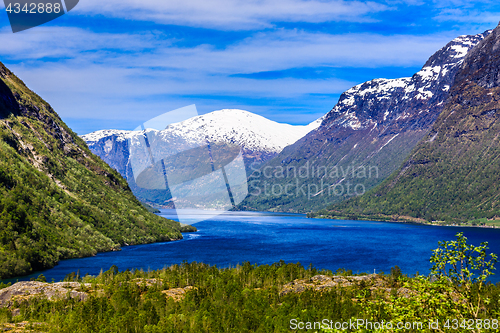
[82,109,322,179]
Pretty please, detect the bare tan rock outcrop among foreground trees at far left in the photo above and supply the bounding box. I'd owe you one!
[0,281,92,307]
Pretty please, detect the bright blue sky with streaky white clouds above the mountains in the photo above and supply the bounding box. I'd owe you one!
[0,0,500,134]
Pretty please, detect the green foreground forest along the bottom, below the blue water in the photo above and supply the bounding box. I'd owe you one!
[0,234,500,333]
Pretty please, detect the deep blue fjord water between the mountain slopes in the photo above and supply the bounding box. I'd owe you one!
[5,211,500,282]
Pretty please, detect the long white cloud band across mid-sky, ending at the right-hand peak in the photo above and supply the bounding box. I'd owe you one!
[0,27,455,70]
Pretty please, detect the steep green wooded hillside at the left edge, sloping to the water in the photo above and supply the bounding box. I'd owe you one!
[0,63,191,278]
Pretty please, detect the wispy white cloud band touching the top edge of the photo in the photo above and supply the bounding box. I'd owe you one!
[75,0,390,30]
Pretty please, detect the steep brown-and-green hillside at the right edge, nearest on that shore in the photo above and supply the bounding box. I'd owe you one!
[320,27,500,222]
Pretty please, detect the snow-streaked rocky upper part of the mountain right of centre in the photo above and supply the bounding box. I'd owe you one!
[325,30,491,132]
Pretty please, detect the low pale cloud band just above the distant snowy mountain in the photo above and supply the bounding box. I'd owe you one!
[10,63,354,113]
